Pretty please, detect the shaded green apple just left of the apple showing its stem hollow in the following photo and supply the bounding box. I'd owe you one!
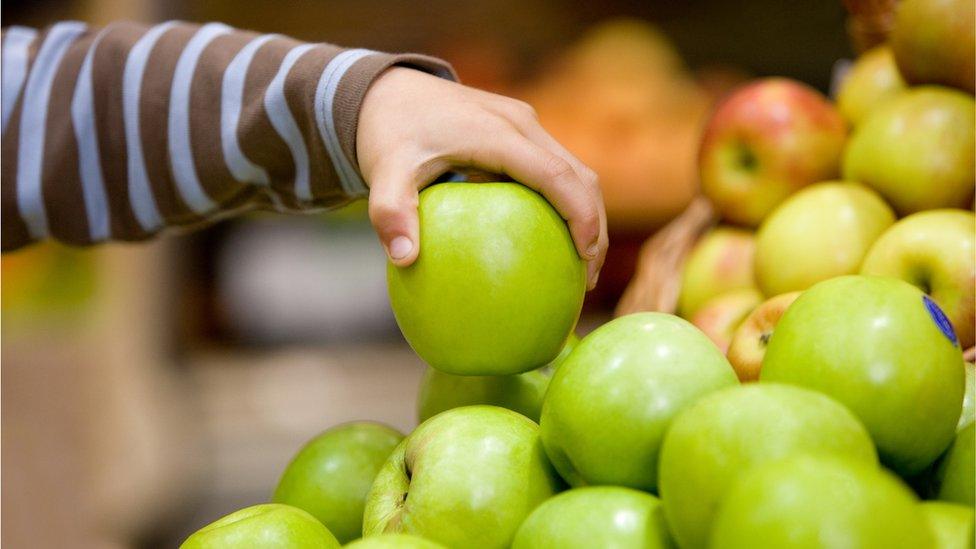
[272,421,403,543]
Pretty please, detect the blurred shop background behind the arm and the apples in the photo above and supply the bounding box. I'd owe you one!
[0,0,851,548]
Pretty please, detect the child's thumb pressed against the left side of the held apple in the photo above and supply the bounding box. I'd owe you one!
[369,170,420,267]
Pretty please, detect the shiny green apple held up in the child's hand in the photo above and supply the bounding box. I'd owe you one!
[387,183,586,375]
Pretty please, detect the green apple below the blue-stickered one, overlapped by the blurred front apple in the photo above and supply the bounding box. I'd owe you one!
[660,383,877,549]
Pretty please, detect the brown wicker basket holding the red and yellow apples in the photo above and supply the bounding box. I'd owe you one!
[614,0,976,362]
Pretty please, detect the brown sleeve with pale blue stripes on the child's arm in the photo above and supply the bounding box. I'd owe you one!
[0,22,455,251]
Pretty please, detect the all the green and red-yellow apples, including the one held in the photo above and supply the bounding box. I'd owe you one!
[183,0,976,549]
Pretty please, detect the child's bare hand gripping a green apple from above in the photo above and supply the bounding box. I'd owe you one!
[356,67,607,288]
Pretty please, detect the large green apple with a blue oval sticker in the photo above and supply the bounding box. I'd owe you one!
[759,276,965,476]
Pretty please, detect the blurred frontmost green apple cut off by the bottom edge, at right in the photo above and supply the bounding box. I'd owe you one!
[709,454,935,549]
